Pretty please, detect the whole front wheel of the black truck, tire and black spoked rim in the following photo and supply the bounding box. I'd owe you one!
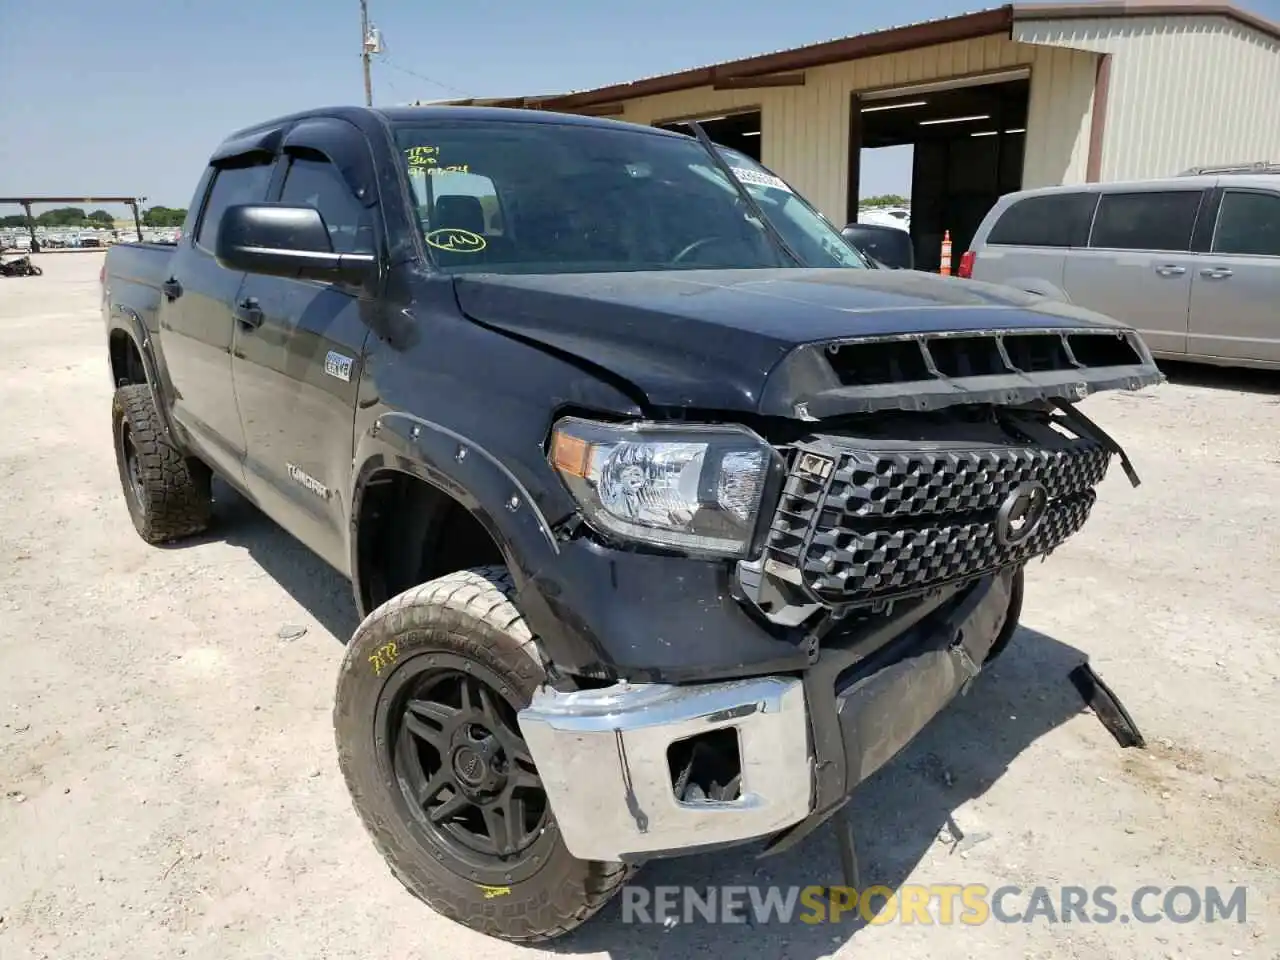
[334,567,630,941]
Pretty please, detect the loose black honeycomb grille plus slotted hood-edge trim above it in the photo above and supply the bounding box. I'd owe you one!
[739,329,1164,626]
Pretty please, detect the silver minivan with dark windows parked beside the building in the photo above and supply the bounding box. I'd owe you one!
[959,168,1280,369]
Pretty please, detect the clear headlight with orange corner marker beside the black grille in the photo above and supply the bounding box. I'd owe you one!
[550,417,776,557]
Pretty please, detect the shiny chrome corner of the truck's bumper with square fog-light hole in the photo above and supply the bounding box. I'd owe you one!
[520,677,813,860]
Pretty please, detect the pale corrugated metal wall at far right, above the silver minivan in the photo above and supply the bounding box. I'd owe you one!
[1014,17,1280,180]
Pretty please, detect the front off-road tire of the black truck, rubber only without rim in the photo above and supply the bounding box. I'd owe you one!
[334,566,634,942]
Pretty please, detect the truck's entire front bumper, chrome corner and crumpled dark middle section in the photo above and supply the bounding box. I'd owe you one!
[520,567,1021,860]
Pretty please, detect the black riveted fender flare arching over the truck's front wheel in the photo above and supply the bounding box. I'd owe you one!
[348,412,561,624]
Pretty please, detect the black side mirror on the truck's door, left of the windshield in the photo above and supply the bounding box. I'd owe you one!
[214,204,378,284]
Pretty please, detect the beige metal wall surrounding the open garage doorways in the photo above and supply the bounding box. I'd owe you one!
[604,36,1097,224]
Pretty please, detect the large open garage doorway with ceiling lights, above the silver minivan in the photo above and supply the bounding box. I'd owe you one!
[847,69,1030,270]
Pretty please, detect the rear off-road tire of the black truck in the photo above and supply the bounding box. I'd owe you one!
[111,384,211,544]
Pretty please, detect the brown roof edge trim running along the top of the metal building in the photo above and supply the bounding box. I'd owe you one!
[443,0,1280,111]
